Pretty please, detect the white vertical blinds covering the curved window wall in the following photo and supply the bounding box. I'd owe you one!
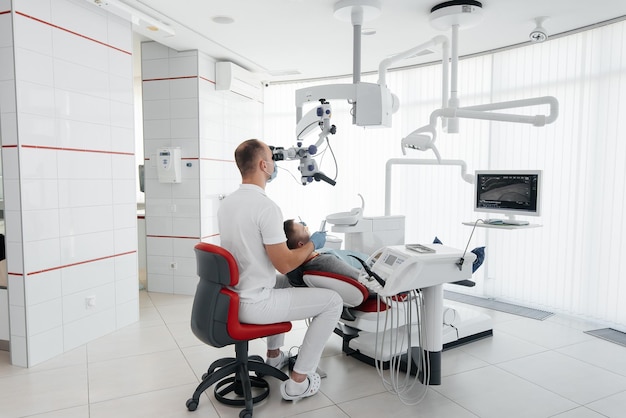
[263,21,626,330]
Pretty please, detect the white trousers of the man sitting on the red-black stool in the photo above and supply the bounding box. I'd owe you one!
[239,284,343,374]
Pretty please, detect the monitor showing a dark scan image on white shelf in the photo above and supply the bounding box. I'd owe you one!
[474,170,542,220]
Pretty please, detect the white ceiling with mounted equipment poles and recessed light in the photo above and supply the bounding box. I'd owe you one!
[122,0,626,82]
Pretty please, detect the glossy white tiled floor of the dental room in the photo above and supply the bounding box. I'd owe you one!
[0,291,626,418]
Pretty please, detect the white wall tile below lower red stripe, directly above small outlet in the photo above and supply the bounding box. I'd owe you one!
[61,258,115,296]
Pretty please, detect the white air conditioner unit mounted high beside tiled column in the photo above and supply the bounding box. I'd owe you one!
[215,62,263,101]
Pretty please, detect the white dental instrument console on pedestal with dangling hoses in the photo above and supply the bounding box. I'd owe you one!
[336,244,476,385]
